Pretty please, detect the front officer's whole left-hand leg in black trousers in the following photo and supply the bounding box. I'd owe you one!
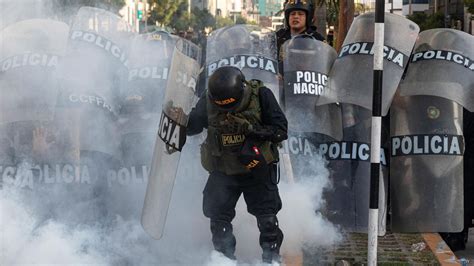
[203,172,241,259]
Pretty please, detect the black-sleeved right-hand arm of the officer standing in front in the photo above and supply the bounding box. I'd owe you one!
[246,87,288,143]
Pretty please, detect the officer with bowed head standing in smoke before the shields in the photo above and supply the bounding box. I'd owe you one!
[187,66,288,263]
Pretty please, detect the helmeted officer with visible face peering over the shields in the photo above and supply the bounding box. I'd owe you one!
[276,0,324,61]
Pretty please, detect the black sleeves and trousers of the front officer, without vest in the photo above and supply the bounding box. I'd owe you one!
[187,87,288,262]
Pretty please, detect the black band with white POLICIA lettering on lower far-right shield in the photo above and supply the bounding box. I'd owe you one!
[392,135,464,156]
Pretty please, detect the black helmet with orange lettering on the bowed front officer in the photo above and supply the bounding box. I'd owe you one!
[208,66,245,110]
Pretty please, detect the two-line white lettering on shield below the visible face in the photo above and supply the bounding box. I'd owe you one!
[285,70,328,95]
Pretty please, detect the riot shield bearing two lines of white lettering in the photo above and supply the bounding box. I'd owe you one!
[283,36,342,140]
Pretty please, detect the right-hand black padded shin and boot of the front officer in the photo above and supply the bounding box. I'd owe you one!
[257,214,283,264]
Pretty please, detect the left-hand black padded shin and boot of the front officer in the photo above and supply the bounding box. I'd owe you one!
[211,220,236,260]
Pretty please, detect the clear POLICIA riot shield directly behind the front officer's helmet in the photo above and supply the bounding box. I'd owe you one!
[206,25,280,100]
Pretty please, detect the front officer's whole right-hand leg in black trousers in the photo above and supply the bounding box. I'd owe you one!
[244,165,283,263]
